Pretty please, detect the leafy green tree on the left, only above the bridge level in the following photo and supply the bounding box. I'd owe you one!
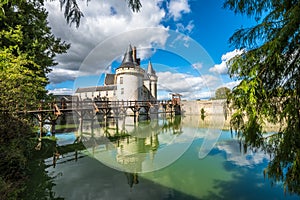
[0,0,69,103]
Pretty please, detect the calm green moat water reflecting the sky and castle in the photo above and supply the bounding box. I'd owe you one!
[28,116,299,200]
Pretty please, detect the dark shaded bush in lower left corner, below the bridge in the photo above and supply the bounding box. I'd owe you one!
[0,112,32,199]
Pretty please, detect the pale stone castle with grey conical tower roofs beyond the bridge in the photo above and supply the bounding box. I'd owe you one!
[75,45,158,101]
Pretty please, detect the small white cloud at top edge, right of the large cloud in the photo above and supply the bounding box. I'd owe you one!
[168,0,191,21]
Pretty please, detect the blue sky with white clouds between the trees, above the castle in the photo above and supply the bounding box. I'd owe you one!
[45,0,255,99]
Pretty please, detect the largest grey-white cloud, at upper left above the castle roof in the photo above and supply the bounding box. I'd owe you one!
[45,0,171,82]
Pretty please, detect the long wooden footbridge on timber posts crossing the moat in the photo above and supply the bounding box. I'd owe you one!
[19,98,181,137]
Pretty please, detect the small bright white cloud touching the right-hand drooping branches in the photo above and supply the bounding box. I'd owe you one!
[209,49,244,74]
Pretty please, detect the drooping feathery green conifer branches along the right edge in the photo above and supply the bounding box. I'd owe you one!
[224,0,300,194]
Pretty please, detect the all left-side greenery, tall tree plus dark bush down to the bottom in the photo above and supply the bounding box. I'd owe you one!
[0,0,69,199]
